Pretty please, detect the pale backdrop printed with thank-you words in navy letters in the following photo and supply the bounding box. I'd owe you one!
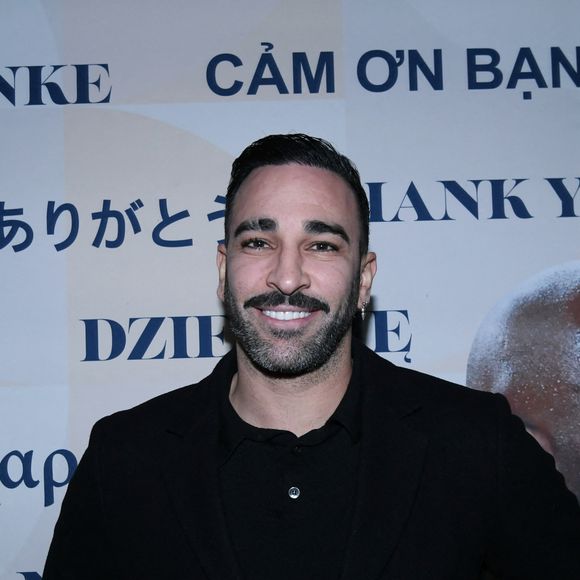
[0,0,580,580]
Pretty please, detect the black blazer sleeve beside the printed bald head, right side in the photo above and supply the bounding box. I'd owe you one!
[489,395,580,580]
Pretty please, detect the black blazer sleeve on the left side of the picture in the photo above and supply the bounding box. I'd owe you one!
[42,423,114,580]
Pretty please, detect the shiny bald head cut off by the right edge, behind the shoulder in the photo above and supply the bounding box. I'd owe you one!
[467,262,580,497]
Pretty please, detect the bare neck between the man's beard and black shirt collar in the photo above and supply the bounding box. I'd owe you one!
[230,335,352,436]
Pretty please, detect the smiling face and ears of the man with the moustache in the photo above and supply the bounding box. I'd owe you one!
[218,164,375,375]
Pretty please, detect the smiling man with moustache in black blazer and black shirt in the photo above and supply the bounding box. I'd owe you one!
[44,135,580,580]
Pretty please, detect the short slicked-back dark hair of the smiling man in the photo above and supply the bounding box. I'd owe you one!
[225,133,369,256]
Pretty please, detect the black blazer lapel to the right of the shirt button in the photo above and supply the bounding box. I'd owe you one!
[342,354,428,580]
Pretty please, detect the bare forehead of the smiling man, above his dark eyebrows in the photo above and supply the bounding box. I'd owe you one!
[231,164,358,231]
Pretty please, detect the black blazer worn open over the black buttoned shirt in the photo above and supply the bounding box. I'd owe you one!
[43,343,580,580]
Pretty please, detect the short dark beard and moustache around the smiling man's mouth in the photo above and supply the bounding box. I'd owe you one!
[224,276,360,377]
